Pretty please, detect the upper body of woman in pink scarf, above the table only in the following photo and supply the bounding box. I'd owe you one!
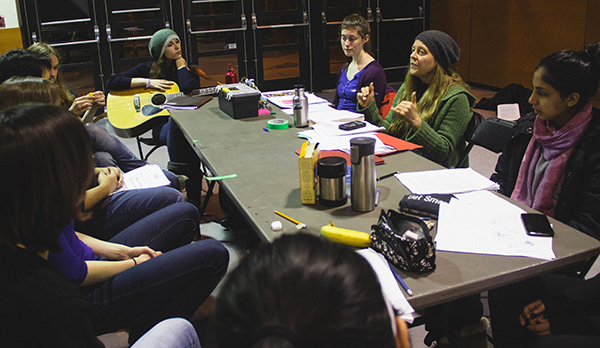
[492,43,600,239]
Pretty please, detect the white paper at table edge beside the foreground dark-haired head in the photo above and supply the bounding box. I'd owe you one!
[357,248,415,323]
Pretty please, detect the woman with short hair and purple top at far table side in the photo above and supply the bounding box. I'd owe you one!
[333,14,393,112]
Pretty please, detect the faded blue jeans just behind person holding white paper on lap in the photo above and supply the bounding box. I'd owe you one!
[86,123,180,189]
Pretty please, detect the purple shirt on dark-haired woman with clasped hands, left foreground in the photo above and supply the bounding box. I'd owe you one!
[48,220,97,286]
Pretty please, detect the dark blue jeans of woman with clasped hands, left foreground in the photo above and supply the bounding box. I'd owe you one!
[81,203,229,344]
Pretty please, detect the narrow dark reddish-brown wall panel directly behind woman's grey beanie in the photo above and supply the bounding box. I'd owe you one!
[429,0,476,81]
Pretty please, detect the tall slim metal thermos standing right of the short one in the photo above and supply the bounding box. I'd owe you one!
[350,138,377,211]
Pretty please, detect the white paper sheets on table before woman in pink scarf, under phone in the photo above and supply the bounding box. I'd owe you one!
[396,168,555,260]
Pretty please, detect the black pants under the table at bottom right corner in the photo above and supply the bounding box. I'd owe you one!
[488,274,600,348]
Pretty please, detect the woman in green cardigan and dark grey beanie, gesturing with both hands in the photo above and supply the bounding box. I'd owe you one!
[357,30,476,168]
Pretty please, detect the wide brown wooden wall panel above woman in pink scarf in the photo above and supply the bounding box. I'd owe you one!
[470,0,588,88]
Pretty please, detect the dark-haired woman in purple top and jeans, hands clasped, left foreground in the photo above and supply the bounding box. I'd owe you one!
[0,104,229,344]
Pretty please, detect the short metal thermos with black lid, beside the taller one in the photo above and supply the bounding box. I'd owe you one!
[317,156,348,207]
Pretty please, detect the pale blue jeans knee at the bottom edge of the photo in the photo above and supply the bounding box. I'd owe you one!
[131,318,200,348]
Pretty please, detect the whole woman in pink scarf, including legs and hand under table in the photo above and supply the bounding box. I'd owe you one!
[488,42,600,348]
